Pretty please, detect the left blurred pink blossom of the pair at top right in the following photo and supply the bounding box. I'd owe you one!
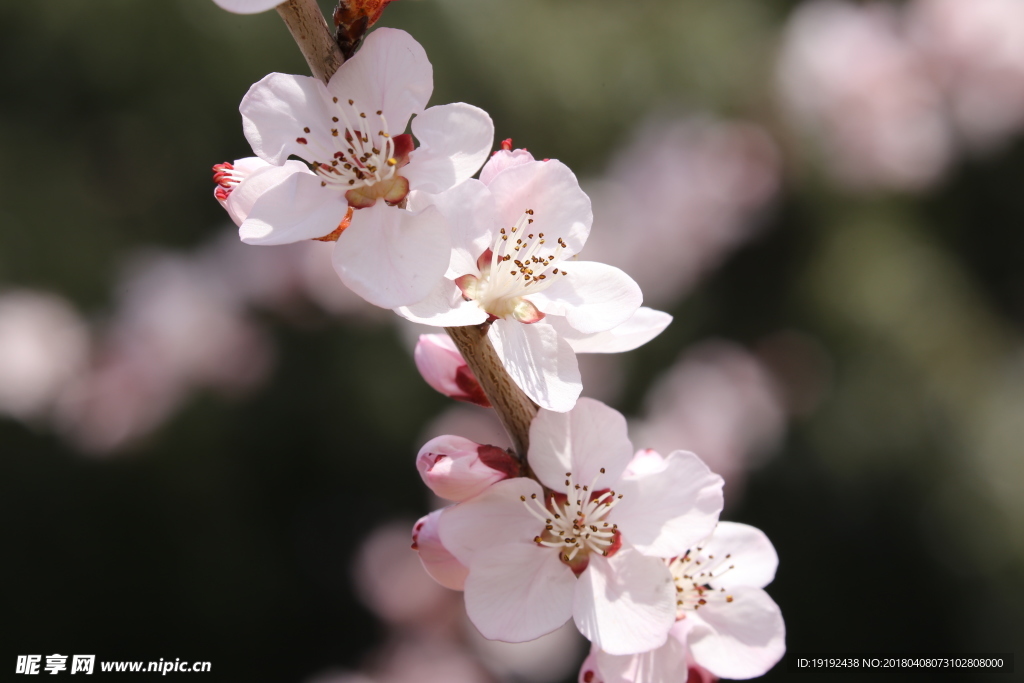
[778,0,950,190]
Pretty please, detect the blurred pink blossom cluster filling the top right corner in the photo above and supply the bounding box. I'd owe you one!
[777,0,1024,191]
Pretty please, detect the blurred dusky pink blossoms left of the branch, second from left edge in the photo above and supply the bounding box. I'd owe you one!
[59,253,271,452]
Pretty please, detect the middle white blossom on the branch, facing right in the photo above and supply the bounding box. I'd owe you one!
[396,158,672,412]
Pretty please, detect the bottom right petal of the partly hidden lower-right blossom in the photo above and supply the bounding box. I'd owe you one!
[687,587,785,679]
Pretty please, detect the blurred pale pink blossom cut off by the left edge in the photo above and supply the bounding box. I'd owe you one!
[0,290,89,420]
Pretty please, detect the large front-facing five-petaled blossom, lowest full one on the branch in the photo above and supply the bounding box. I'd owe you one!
[438,398,722,654]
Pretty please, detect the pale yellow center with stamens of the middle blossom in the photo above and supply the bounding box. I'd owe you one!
[456,209,568,323]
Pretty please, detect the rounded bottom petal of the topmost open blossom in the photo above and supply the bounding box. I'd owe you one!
[334,202,452,308]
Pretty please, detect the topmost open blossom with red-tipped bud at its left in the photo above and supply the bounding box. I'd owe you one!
[233,29,494,308]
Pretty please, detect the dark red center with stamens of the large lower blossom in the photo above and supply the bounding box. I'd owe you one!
[520,467,623,575]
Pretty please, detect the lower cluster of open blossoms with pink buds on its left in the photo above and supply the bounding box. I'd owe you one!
[413,398,785,683]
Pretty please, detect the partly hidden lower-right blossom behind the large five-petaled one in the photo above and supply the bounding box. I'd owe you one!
[580,518,785,683]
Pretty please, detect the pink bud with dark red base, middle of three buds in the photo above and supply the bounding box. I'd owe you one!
[416,436,520,502]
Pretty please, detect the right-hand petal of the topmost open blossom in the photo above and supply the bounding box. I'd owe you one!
[401,102,495,194]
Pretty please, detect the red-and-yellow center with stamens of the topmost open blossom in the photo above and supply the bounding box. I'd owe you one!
[295,97,413,209]
